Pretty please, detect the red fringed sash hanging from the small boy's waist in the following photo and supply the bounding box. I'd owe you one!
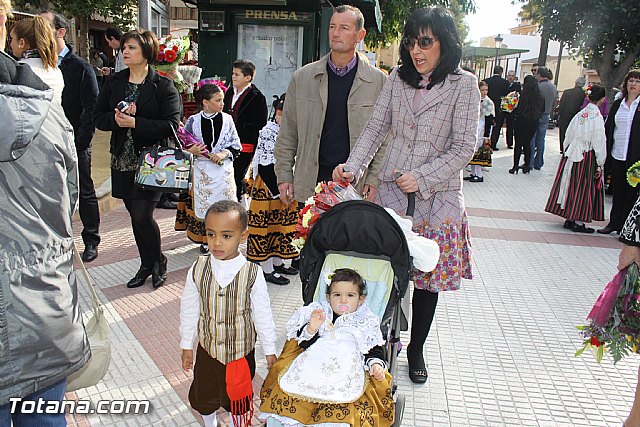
[225,357,253,427]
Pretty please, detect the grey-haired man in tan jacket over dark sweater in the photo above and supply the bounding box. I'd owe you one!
[275,5,386,204]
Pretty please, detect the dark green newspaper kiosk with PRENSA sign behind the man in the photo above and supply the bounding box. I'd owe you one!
[189,0,382,104]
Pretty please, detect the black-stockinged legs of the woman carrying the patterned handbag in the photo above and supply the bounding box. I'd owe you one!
[124,199,162,268]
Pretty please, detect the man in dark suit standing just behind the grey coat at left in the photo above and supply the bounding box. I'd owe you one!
[41,11,100,262]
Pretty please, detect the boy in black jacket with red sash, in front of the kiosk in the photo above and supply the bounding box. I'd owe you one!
[222,59,267,202]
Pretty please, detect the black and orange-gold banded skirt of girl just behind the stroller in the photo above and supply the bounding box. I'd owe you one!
[247,175,298,262]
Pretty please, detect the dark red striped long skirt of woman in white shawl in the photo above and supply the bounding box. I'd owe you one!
[544,150,604,222]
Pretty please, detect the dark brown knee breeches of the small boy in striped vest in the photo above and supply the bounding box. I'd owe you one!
[189,344,256,415]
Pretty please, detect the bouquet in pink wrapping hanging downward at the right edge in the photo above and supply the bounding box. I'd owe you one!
[576,263,640,364]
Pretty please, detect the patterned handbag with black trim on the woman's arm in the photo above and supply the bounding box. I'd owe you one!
[135,129,193,193]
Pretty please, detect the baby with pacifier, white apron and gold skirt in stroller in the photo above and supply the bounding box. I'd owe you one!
[260,268,394,426]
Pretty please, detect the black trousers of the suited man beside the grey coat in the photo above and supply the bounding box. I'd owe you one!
[78,149,100,246]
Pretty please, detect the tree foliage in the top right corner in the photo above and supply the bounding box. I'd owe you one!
[516,0,640,101]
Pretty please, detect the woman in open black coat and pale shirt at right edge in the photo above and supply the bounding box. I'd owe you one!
[598,70,640,234]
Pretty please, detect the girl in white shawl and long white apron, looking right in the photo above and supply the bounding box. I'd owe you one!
[175,84,242,253]
